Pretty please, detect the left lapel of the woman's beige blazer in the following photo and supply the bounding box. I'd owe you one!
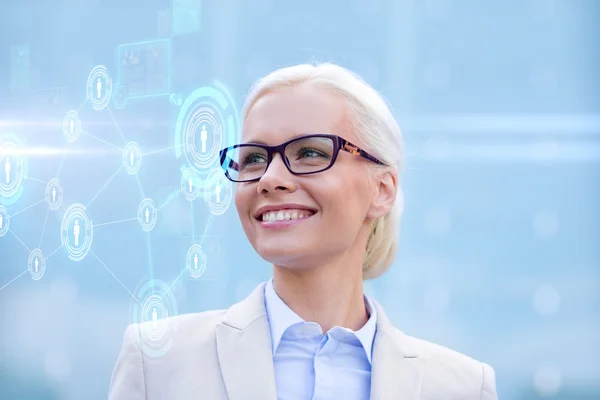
[217,283,277,400]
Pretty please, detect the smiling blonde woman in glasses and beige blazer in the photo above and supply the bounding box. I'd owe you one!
[110,63,497,400]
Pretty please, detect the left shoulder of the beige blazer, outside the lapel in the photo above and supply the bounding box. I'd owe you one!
[109,310,232,400]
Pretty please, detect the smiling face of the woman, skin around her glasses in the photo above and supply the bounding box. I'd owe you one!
[235,84,395,268]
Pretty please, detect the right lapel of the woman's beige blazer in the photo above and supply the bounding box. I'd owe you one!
[371,301,423,400]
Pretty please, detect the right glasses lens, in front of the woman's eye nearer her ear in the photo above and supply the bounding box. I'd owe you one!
[285,136,334,174]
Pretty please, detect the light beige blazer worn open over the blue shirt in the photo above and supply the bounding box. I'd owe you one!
[109,283,498,400]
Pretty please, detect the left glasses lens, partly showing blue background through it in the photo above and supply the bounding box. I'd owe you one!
[222,145,267,181]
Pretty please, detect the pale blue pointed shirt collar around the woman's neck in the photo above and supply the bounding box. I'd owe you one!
[265,278,377,363]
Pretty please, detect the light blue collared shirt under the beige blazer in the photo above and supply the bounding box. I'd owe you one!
[265,279,377,400]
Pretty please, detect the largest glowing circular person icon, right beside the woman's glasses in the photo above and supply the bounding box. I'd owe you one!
[174,82,240,184]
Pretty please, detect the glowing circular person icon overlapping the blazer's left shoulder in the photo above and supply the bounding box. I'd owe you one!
[131,280,177,358]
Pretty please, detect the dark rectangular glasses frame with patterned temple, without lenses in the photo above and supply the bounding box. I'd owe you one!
[219,133,386,182]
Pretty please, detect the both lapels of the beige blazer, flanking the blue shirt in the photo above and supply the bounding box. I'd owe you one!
[216,282,423,400]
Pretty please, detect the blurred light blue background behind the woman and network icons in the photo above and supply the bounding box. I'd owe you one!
[0,0,600,400]
